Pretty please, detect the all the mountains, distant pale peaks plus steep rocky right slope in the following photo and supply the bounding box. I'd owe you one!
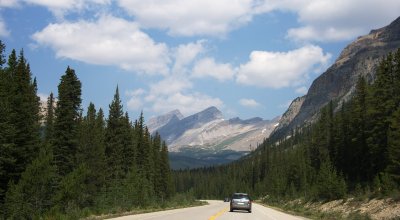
[148,17,400,168]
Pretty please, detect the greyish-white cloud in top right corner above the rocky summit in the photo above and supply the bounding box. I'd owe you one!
[259,0,400,42]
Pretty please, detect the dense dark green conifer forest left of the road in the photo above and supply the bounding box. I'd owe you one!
[0,42,174,219]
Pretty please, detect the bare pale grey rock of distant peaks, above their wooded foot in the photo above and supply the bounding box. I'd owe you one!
[155,107,278,152]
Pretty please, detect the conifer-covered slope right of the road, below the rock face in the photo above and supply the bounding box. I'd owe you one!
[174,50,400,201]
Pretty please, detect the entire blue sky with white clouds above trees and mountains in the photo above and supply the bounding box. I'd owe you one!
[0,0,400,119]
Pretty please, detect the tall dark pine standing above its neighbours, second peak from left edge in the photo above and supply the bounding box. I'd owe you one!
[54,67,81,176]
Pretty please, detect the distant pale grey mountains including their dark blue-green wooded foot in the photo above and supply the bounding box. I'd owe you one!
[147,106,278,168]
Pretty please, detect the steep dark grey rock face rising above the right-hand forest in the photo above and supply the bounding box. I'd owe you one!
[274,17,400,136]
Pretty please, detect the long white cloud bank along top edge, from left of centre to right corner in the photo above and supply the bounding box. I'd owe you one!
[118,0,400,41]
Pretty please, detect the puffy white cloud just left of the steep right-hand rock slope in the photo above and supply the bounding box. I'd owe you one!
[236,45,331,89]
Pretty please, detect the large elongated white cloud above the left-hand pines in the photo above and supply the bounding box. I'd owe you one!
[32,16,169,74]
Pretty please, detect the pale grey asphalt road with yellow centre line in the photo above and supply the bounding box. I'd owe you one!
[108,200,305,220]
